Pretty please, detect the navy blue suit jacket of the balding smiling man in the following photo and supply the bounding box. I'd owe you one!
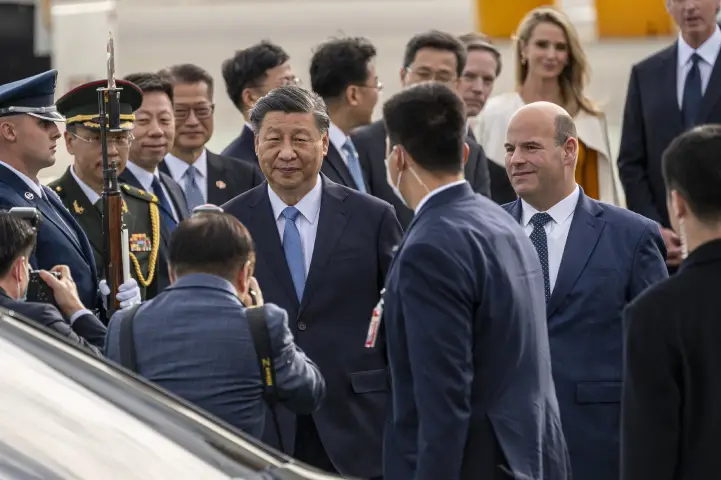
[504,191,668,480]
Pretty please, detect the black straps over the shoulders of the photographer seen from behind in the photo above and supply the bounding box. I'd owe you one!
[120,304,285,452]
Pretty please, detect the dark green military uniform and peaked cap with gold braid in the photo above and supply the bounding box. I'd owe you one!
[48,80,161,300]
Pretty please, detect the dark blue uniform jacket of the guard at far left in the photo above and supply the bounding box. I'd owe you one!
[0,165,101,309]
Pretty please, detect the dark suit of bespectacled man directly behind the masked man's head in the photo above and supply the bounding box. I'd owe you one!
[351,120,491,229]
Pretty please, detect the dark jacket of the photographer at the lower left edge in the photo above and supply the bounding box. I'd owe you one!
[0,288,106,356]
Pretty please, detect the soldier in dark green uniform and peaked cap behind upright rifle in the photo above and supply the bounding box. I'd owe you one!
[50,80,160,299]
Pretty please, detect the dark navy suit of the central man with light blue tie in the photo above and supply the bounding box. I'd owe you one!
[223,175,401,478]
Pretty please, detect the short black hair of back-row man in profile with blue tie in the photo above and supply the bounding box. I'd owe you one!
[310,37,376,101]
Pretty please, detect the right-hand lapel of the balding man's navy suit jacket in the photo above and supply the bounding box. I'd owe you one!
[546,190,606,319]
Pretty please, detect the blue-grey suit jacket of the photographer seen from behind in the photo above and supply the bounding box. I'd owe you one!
[105,274,325,438]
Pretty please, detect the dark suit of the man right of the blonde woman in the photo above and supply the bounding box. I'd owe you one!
[618,43,721,228]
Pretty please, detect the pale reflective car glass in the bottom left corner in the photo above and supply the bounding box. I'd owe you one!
[0,338,236,479]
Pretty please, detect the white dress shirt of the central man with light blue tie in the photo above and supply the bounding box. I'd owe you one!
[268,175,323,278]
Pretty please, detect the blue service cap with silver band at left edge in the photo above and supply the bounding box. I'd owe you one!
[0,70,65,122]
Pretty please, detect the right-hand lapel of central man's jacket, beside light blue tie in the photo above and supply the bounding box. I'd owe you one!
[298,175,348,316]
